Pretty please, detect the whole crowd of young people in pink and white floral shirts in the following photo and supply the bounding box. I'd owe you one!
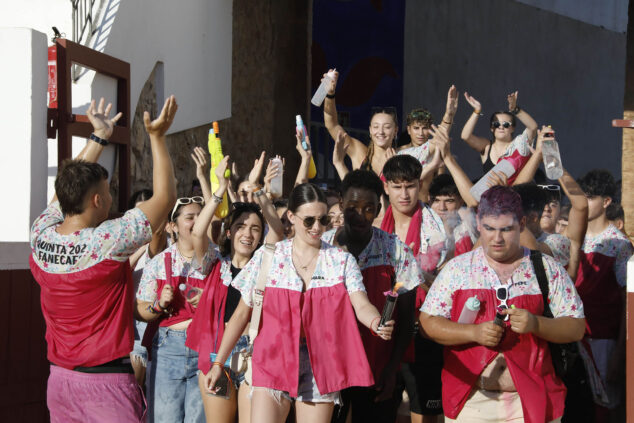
[31,67,634,423]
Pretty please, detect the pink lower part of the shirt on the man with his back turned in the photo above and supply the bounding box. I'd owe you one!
[29,256,134,370]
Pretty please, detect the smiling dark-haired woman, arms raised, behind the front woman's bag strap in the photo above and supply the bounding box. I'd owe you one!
[185,156,284,423]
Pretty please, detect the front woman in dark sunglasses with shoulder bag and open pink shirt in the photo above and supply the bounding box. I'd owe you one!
[205,183,394,423]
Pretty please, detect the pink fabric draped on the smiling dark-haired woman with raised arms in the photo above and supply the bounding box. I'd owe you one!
[185,260,228,373]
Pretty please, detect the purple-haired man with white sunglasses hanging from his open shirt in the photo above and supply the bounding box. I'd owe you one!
[420,186,585,423]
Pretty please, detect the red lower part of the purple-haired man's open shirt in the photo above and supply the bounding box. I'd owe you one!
[442,289,566,423]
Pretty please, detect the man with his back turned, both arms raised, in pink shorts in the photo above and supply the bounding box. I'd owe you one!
[30,96,177,422]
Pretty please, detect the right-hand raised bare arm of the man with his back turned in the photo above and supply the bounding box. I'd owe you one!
[139,96,178,231]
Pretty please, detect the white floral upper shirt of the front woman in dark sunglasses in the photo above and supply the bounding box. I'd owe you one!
[231,239,365,307]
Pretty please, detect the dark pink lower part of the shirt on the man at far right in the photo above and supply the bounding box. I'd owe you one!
[575,252,624,339]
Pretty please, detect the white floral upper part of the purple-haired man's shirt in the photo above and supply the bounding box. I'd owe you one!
[421,247,584,319]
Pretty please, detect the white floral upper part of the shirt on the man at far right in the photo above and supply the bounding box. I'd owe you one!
[582,224,634,286]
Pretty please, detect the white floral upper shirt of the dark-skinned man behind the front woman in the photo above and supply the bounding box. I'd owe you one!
[321,226,423,291]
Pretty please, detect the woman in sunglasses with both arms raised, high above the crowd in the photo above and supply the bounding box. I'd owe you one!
[460,91,537,185]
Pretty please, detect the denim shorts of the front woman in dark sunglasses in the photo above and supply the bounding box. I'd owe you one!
[251,340,341,405]
